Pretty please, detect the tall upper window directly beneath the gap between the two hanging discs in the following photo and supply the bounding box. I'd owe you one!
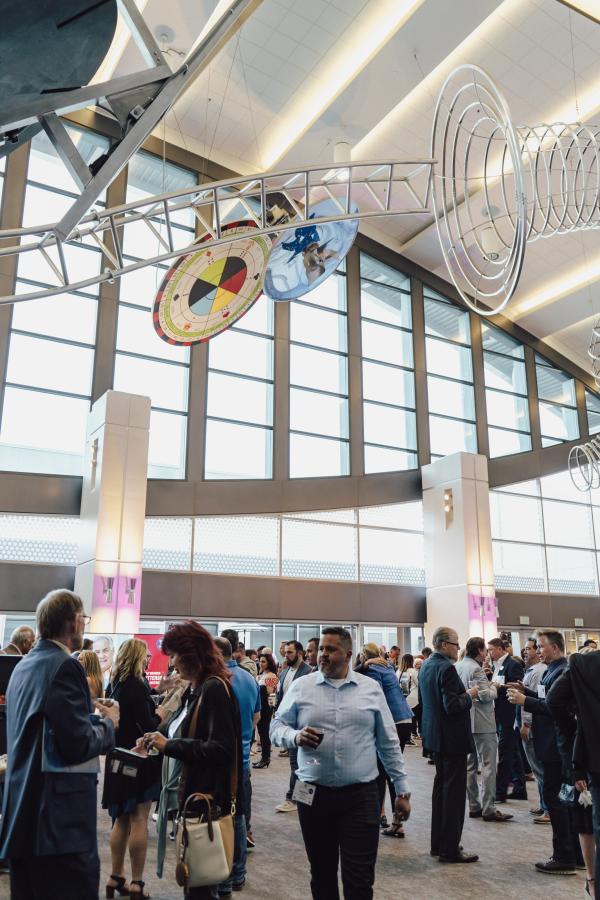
[204,295,274,479]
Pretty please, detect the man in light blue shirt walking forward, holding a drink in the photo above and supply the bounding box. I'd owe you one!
[271,627,410,900]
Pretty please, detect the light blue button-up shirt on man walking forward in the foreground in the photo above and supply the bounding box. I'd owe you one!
[271,668,409,794]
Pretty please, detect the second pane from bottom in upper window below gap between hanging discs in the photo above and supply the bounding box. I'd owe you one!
[207,372,273,425]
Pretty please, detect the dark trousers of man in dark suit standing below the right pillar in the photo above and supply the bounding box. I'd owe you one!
[431,753,467,857]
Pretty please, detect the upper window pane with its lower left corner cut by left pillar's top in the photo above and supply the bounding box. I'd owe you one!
[114,353,188,412]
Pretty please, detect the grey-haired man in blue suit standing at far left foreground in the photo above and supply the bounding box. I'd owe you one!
[0,590,119,900]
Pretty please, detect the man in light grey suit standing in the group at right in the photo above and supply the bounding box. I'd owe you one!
[456,637,512,822]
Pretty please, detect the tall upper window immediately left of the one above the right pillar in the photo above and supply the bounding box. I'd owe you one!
[360,253,417,474]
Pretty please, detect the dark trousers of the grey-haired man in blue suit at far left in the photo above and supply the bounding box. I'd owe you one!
[10,849,100,900]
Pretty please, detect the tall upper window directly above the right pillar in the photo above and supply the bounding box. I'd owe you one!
[423,285,477,459]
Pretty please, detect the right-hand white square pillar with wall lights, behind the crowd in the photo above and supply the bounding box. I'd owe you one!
[422,453,498,647]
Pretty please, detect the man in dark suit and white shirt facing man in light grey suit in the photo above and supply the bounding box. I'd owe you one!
[488,638,527,803]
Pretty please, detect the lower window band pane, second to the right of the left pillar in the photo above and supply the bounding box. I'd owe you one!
[194,516,279,575]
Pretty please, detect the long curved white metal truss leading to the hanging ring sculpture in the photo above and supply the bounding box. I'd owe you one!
[0,159,434,304]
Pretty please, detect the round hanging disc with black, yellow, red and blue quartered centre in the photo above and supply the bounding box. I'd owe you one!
[152,221,271,345]
